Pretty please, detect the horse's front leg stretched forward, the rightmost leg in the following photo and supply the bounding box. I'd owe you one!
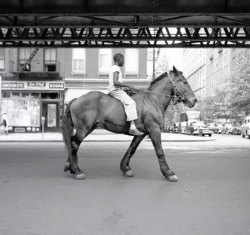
[149,128,178,182]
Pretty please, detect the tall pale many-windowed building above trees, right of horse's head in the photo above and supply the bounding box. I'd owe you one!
[183,48,237,98]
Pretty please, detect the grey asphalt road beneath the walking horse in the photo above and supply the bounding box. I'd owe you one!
[0,136,250,235]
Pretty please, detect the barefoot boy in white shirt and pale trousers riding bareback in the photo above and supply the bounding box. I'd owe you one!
[108,53,144,135]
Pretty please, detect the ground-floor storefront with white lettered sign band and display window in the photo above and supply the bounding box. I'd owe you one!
[1,81,65,132]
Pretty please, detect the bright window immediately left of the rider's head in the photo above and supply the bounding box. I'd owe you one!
[99,49,112,73]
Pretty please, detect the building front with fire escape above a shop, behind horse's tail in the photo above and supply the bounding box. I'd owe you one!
[1,48,65,132]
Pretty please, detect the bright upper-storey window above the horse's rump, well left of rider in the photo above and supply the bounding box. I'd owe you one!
[72,48,86,74]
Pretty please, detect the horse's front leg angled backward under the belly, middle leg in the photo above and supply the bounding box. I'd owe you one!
[120,135,146,177]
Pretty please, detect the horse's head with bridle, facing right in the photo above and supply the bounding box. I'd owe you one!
[169,66,197,108]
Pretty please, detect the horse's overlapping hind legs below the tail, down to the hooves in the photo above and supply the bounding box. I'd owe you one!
[64,128,94,179]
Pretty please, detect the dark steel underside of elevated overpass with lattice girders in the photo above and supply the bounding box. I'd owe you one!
[0,0,250,48]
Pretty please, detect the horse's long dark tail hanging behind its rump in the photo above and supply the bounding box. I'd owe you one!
[62,99,75,151]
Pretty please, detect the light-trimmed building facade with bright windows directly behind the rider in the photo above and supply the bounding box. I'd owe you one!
[63,48,149,103]
